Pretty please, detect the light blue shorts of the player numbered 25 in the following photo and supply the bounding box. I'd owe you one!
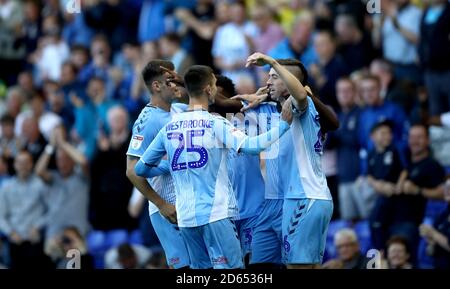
[180,218,244,269]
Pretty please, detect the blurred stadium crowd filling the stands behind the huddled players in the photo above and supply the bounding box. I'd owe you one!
[0,0,450,268]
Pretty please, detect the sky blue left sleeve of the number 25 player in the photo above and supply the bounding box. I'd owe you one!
[134,128,166,177]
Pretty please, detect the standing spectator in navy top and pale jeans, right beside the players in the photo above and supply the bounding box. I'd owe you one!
[330,78,368,220]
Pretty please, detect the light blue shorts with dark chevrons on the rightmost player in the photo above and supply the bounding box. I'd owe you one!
[282,199,333,264]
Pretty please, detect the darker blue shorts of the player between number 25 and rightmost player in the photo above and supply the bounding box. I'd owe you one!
[250,200,283,264]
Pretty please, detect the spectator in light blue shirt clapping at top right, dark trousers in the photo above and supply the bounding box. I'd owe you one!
[382,0,422,82]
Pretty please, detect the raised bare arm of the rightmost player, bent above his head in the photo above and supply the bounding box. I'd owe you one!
[246,52,308,111]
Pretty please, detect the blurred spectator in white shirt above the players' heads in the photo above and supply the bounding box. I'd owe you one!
[212,1,257,84]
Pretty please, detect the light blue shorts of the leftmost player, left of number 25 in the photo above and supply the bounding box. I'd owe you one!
[150,212,191,269]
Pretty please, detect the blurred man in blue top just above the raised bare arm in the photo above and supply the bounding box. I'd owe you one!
[268,13,317,67]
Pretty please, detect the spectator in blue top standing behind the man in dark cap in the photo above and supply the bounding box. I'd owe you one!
[358,75,409,174]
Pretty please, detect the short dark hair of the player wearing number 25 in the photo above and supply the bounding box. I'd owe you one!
[184,65,214,96]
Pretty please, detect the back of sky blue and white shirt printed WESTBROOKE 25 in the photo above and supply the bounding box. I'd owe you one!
[161,111,239,227]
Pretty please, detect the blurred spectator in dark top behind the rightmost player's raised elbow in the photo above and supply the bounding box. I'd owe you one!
[309,30,346,111]
